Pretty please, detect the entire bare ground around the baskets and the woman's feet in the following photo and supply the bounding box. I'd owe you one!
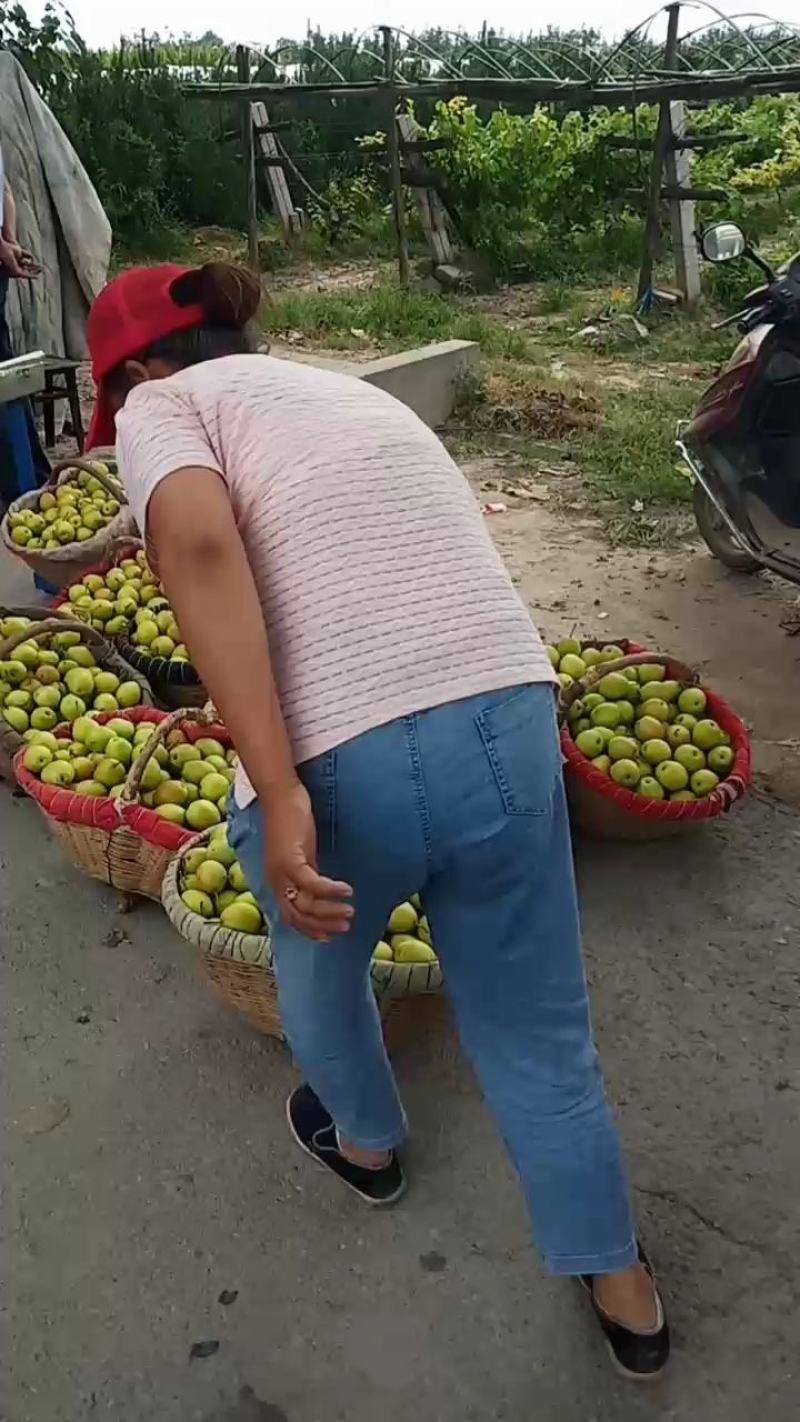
[0,429,800,1422]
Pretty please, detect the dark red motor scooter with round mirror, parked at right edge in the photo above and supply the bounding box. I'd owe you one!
[676,222,800,583]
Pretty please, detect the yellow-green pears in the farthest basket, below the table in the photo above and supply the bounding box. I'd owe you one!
[9,459,122,552]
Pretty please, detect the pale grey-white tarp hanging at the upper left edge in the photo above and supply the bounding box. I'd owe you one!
[0,51,111,360]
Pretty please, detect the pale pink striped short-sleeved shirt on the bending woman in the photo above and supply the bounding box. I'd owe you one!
[117,356,553,805]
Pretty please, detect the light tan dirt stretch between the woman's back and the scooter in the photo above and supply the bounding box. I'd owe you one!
[463,459,800,805]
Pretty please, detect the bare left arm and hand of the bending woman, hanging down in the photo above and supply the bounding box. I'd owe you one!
[148,468,352,939]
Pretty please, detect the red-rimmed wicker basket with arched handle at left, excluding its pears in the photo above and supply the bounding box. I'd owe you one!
[14,707,230,900]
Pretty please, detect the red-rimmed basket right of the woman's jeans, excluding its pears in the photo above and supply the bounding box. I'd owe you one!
[560,640,752,839]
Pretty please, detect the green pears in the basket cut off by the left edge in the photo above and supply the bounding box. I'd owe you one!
[0,617,142,741]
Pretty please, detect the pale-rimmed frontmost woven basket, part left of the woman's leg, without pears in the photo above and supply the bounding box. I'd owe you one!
[161,833,283,1041]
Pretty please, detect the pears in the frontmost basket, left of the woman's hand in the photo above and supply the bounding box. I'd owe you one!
[179,825,269,963]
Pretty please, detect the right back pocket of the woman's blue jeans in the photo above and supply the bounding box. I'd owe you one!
[476,683,561,815]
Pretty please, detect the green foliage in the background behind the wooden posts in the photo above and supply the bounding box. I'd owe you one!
[0,0,800,273]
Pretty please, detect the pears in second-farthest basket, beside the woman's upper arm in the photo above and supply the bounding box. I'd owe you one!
[67,549,190,661]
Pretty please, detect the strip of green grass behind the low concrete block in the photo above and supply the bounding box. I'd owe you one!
[261,283,527,358]
